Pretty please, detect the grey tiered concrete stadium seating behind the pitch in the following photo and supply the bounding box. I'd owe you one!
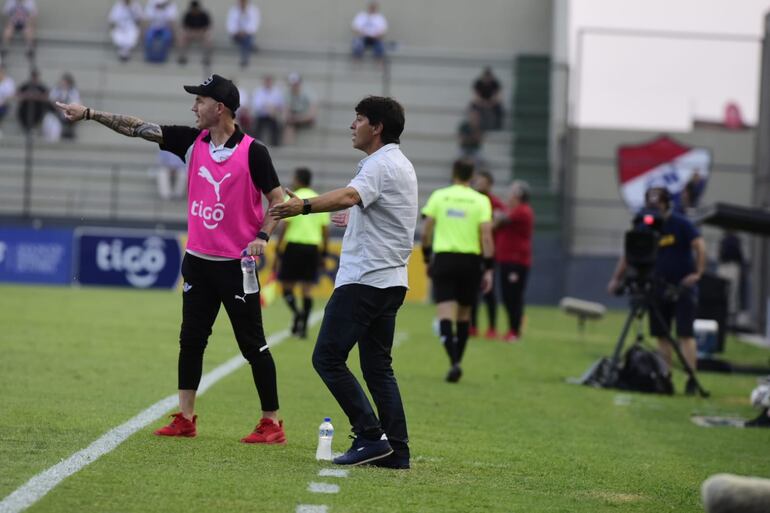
[0,37,513,225]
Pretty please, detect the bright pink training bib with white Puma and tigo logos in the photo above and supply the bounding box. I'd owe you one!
[187,130,264,258]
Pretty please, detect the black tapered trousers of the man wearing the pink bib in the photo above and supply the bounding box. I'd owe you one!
[179,253,278,411]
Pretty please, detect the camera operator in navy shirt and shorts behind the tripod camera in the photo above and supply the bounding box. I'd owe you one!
[607,187,706,395]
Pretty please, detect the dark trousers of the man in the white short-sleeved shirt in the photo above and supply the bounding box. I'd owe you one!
[313,284,409,457]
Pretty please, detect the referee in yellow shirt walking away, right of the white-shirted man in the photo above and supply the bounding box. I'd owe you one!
[422,160,494,383]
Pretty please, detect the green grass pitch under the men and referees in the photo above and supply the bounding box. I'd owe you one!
[0,286,770,513]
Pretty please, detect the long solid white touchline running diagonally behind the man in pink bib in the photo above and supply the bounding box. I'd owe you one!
[0,311,323,513]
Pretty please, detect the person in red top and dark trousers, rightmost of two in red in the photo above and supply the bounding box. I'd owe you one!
[494,180,535,342]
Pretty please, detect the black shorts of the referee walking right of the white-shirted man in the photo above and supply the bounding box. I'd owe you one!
[430,253,481,306]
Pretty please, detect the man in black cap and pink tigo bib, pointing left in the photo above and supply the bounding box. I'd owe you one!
[57,75,286,444]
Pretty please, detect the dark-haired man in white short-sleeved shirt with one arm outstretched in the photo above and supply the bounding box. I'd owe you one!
[270,96,417,469]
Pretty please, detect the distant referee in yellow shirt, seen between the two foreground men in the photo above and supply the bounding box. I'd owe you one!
[276,167,329,338]
